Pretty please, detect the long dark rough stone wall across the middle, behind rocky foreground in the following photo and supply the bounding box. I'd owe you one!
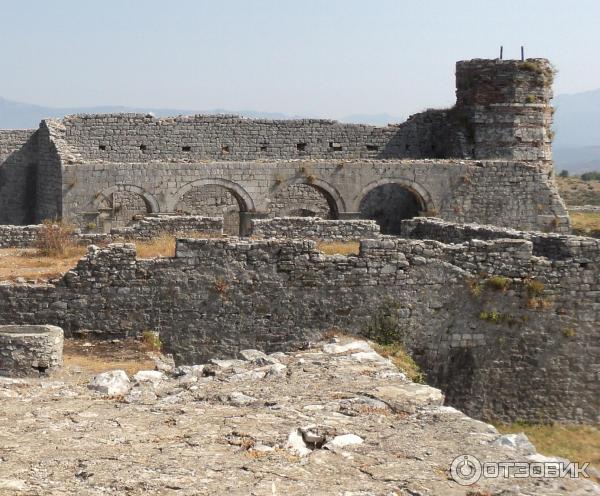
[0,227,600,422]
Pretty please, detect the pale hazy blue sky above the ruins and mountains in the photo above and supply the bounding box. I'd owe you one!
[0,0,600,117]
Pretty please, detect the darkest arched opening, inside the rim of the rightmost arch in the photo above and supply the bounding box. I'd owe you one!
[359,183,425,234]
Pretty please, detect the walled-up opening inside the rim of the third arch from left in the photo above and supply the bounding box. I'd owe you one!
[269,183,339,219]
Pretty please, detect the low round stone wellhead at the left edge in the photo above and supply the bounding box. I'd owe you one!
[0,325,63,377]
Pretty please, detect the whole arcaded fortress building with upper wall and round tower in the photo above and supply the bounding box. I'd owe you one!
[0,59,569,234]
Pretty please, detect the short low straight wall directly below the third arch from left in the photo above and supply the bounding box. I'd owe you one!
[250,217,380,241]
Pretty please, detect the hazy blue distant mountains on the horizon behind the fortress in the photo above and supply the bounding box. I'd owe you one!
[0,89,600,174]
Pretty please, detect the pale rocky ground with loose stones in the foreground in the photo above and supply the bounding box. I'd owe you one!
[0,341,600,496]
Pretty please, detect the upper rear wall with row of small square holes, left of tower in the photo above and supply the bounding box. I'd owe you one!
[56,111,454,162]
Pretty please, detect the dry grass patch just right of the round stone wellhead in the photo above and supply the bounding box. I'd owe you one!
[63,339,154,376]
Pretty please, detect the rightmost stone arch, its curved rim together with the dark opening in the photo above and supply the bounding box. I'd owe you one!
[355,179,434,234]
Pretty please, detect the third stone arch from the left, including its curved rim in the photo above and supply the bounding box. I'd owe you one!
[269,177,346,219]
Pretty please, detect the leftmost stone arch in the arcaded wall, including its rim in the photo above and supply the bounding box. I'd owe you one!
[92,184,161,230]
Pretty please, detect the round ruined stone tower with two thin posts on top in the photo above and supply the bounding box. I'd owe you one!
[455,59,554,168]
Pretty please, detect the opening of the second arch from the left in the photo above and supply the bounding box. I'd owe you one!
[175,184,246,236]
